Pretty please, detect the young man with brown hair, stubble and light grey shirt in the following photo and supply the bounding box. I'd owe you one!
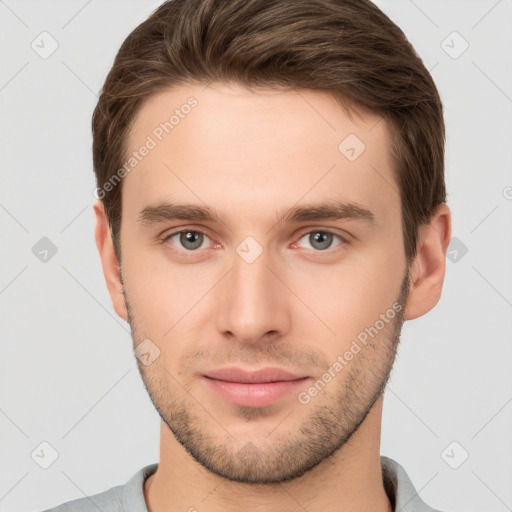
[45,0,451,512]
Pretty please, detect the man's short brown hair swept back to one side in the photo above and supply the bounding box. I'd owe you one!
[92,0,446,264]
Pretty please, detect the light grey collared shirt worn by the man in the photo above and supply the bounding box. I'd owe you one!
[44,456,439,512]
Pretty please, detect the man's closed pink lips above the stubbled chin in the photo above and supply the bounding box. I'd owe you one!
[203,368,309,407]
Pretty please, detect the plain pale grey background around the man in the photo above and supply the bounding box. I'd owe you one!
[0,0,512,512]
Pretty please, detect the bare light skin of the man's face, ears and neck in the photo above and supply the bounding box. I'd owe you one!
[95,83,451,512]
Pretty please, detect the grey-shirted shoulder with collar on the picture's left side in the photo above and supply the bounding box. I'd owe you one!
[38,463,158,512]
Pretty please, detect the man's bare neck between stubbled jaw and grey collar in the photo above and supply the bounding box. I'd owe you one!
[144,397,392,512]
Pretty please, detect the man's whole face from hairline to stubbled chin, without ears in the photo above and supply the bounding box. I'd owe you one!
[115,84,409,483]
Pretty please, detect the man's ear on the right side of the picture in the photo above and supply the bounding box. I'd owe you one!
[404,203,452,320]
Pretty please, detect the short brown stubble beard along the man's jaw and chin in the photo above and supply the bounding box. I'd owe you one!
[123,272,410,484]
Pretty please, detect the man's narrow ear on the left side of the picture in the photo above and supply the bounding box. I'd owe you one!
[94,200,128,321]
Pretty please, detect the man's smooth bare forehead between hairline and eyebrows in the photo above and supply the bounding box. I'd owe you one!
[123,84,399,227]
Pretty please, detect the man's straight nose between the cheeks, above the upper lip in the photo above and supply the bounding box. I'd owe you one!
[217,244,291,343]
